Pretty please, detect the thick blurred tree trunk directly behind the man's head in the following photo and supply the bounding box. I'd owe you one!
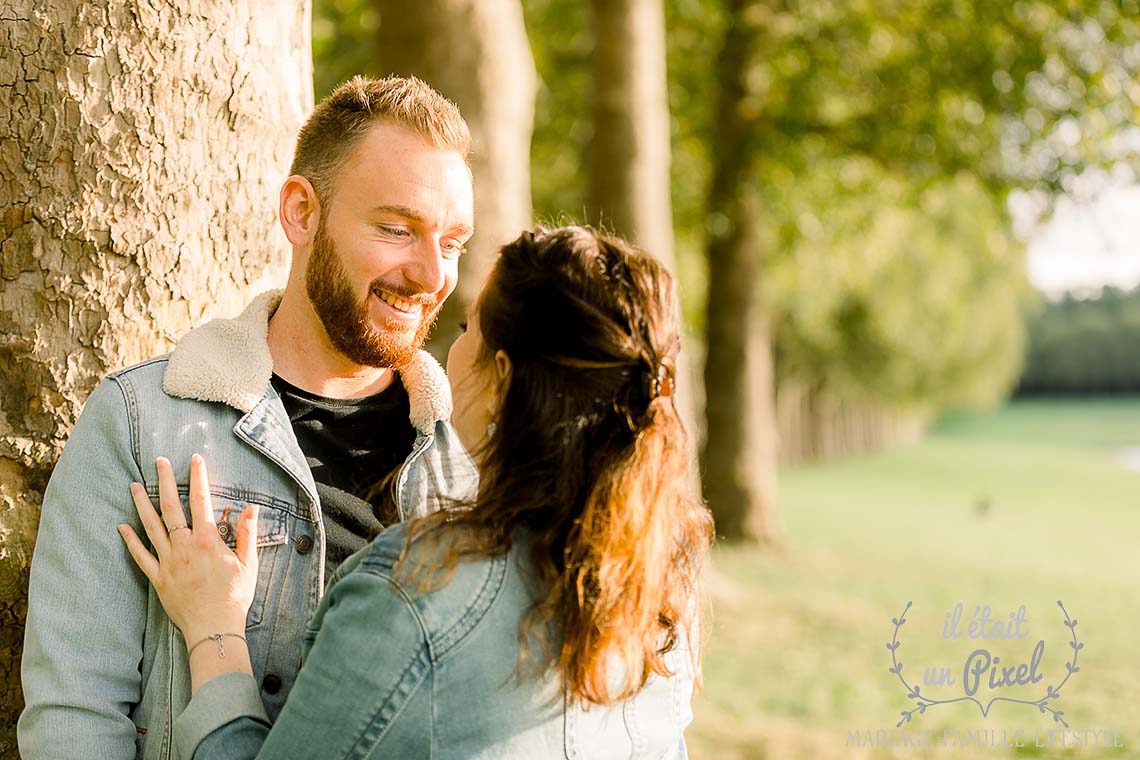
[375,0,537,358]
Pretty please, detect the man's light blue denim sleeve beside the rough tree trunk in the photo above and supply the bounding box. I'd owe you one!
[17,378,147,760]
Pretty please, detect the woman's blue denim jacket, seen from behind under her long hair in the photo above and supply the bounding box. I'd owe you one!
[174,525,693,760]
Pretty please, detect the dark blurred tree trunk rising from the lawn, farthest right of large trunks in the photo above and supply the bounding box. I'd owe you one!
[701,0,783,544]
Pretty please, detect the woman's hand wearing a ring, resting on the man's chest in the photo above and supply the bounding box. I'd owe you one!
[119,455,258,647]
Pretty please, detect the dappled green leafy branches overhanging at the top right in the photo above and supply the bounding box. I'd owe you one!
[670,0,1140,194]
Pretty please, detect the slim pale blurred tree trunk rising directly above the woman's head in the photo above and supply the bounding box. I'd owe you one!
[586,0,700,480]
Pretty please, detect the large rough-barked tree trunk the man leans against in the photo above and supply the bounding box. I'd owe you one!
[0,0,312,758]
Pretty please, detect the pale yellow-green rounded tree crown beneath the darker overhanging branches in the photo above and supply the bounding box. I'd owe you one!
[770,167,1028,407]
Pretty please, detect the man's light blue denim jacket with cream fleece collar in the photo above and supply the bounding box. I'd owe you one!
[18,292,477,760]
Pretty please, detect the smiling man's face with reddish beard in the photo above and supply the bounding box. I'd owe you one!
[304,124,473,367]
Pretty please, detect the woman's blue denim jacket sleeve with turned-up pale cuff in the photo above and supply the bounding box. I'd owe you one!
[174,571,431,760]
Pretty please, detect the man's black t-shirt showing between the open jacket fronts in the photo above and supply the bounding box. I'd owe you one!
[272,375,416,581]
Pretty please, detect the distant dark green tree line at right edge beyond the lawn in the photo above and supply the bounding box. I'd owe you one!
[1018,288,1140,393]
